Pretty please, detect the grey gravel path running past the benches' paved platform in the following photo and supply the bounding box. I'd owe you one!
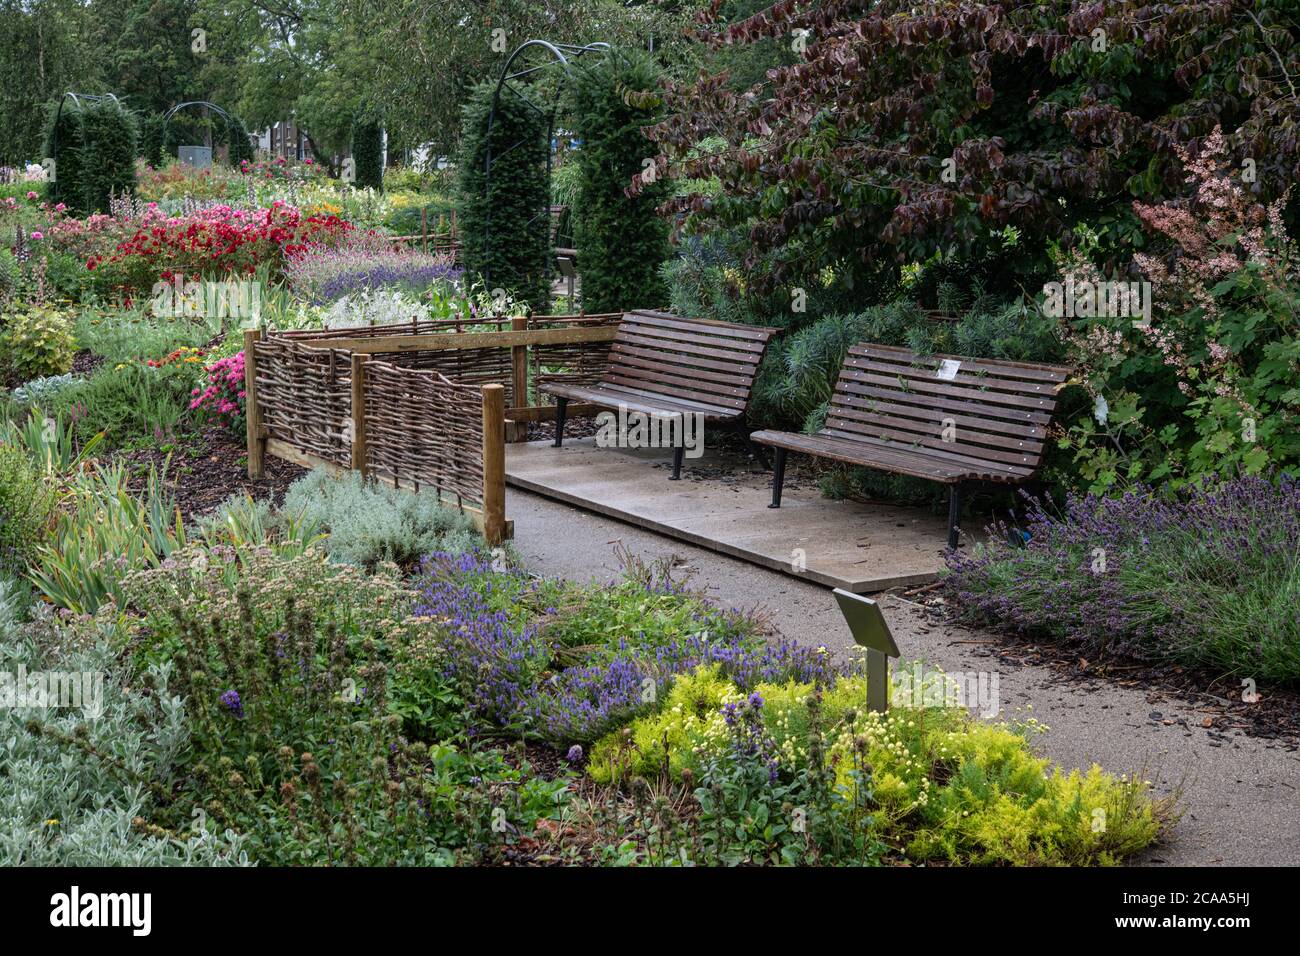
[506,489,1300,866]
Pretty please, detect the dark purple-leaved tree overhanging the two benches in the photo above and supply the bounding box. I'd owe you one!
[653,0,1300,290]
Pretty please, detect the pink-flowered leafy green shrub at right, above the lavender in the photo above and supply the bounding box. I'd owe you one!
[1062,130,1300,492]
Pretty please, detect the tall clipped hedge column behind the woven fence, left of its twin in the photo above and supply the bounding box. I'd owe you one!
[456,83,551,312]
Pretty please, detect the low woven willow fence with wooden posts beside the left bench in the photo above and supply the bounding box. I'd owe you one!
[244,313,620,545]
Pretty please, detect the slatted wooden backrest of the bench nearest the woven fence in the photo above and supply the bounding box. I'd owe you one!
[602,312,776,412]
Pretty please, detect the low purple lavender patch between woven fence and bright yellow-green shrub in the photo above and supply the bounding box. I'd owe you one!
[417,553,835,745]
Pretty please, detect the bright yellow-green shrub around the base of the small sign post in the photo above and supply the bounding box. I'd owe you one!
[589,667,1171,865]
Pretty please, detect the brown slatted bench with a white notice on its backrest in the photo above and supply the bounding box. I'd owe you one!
[750,342,1070,548]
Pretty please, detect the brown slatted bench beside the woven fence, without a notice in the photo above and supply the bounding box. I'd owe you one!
[541,311,776,480]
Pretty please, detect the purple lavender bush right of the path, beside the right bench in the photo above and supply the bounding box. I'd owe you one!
[944,476,1300,683]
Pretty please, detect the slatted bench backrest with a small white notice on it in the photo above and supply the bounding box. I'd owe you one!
[823,342,1070,471]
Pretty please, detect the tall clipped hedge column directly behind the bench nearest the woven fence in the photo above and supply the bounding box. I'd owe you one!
[572,49,668,312]
